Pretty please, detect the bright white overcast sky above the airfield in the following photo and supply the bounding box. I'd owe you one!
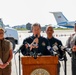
[0,0,76,26]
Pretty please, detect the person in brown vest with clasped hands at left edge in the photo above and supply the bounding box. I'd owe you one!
[0,28,13,75]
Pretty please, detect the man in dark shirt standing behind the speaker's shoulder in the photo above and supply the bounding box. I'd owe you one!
[46,25,64,75]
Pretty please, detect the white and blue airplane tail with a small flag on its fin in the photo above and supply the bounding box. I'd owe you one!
[50,12,76,28]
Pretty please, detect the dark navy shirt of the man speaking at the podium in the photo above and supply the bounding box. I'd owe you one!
[21,36,50,55]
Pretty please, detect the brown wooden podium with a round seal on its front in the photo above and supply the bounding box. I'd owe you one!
[21,56,58,75]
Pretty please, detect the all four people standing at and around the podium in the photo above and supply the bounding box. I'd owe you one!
[0,23,76,75]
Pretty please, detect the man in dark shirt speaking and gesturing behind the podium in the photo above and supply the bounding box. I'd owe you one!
[21,23,50,56]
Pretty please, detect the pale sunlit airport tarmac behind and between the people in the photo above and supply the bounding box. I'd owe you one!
[12,30,74,75]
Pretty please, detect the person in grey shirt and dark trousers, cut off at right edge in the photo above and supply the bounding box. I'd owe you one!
[66,23,76,75]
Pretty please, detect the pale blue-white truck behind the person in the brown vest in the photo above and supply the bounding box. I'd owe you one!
[0,18,19,50]
